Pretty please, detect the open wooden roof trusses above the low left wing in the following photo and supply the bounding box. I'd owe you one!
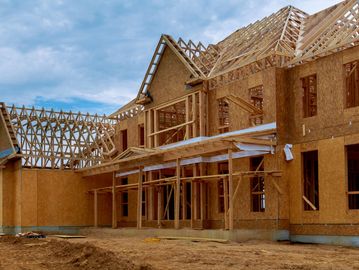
[3,103,117,169]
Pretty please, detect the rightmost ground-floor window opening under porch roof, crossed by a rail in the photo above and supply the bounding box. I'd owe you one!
[250,157,265,212]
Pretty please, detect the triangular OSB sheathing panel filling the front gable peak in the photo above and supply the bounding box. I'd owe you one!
[146,47,191,109]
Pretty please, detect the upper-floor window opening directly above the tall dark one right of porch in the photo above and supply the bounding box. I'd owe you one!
[301,74,317,118]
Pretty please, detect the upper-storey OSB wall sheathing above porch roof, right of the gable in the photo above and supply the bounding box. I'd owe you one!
[208,68,276,136]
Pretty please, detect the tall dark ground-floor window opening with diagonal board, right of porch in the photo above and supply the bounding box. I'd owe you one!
[302,151,319,211]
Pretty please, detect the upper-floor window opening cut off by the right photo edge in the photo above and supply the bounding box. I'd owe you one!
[344,61,359,108]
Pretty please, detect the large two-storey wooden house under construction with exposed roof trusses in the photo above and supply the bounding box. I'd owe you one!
[0,0,359,245]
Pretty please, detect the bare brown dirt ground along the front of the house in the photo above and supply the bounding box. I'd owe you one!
[0,236,359,270]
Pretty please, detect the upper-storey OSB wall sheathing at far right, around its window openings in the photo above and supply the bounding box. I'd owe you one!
[286,47,359,146]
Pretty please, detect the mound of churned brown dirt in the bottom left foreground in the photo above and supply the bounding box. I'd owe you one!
[0,237,154,270]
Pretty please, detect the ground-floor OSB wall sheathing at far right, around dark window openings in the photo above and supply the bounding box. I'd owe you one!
[285,136,359,224]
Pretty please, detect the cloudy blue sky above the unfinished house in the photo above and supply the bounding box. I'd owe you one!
[0,0,339,114]
